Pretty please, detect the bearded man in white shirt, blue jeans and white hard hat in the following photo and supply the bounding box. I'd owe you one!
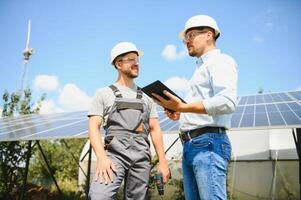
[154,15,237,200]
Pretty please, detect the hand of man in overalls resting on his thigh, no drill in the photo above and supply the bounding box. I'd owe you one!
[95,156,117,184]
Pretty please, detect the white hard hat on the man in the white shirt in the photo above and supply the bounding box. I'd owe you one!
[179,15,221,40]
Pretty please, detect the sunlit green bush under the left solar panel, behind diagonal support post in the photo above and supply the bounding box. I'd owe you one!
[29,139,87,191]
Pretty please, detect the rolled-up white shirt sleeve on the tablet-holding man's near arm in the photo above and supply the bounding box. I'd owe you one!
[203,55,237,116]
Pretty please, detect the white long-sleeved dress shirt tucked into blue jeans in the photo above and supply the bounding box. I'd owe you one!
[180,49,237,131]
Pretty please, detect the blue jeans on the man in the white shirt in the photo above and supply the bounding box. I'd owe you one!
[182,133,231,200]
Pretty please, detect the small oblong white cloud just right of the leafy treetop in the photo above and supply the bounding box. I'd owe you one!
[33,75,59,91]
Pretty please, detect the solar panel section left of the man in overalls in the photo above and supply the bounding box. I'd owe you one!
[0,111,87,141]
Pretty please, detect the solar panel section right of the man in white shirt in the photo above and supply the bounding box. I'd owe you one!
[231,91,301,129]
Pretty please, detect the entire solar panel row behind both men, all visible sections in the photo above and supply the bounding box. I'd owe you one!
[0,91,301,141]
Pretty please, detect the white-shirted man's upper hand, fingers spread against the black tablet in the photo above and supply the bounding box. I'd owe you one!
[152,90,185,112]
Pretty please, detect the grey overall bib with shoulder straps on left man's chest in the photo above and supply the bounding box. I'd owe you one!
[108,85,145,132]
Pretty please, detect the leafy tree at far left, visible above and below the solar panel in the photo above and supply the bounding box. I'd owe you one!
[0,89,45,199]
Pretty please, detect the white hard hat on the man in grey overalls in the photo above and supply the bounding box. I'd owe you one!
[110,42,144,65]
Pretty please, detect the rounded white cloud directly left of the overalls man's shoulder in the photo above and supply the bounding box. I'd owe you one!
[58,83,92,111]
